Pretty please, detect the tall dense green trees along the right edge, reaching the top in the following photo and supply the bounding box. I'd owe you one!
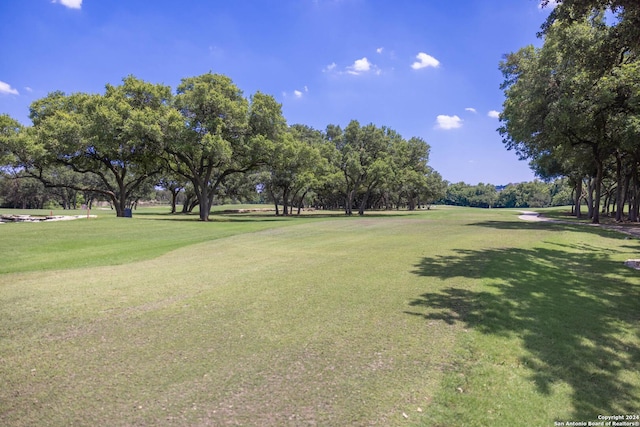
[499,0,640,223]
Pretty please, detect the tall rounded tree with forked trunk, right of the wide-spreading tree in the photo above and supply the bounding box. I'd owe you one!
[165,73,286,221]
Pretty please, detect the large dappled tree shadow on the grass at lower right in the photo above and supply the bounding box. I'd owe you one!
[406,234,640,419]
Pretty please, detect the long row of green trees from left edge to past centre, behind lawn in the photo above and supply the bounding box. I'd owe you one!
[0,73,445,221]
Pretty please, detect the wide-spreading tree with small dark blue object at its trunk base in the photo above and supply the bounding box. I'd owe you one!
[13,76,171,216]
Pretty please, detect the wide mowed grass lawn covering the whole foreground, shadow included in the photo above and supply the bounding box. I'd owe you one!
[0,208,640,426]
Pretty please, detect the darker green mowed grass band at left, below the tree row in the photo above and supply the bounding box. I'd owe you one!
[0,209,322,274]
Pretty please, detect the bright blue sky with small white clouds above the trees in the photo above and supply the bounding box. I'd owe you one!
[0,0,548,185]
